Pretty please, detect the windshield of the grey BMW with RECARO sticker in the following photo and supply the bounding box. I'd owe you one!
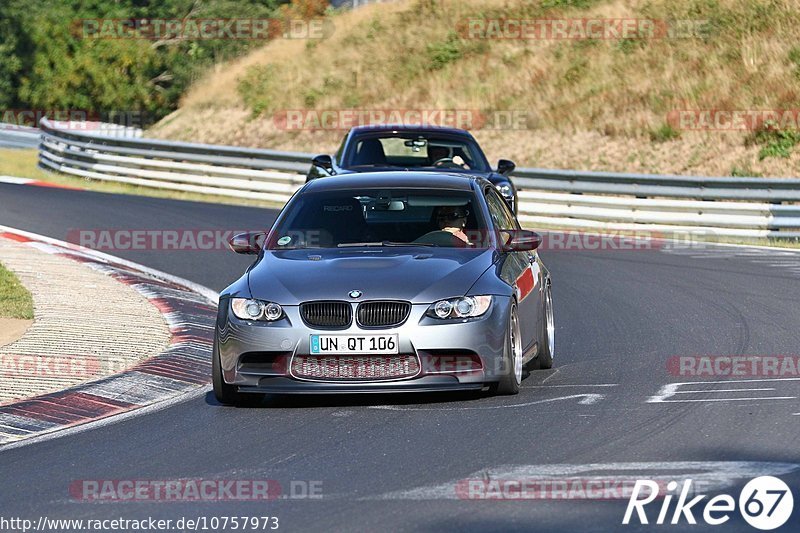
[267,189,488,250]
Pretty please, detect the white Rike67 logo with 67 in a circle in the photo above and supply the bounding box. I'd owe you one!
[622,476,794,530]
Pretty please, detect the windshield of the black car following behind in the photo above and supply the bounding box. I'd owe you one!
[343,132,490,172]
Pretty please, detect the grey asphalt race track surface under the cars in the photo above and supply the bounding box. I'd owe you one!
[0,184,800,531]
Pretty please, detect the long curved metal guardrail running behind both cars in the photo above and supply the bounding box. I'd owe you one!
[39,119,800,238]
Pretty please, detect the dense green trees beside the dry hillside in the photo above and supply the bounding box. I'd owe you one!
[0,0,298,119]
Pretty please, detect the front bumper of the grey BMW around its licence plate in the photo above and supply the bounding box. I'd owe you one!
[215,296,509,394]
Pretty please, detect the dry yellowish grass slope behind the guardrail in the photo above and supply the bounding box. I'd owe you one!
[152,0,800,176]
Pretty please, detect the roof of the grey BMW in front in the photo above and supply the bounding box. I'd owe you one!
[303,171,480,192]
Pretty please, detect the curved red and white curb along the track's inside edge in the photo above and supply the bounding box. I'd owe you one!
[0,226,218,449]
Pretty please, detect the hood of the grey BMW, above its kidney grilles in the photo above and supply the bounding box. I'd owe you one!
[248,247,494,305]
